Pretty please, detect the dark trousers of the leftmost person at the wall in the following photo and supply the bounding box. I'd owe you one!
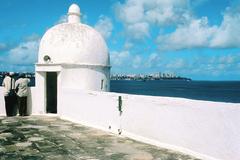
[4,96,17,116]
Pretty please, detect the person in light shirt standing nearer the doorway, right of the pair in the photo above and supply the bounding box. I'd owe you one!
[15,74,30,116]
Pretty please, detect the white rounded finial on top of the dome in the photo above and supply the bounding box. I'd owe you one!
[68,4,80,23]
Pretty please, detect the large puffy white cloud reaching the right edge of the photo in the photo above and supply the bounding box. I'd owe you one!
[157,5,240,50]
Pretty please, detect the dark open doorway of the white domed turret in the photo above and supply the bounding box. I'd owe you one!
[46,72,57,113]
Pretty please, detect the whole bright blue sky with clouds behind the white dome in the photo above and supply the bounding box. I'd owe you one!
[0,0,240,80]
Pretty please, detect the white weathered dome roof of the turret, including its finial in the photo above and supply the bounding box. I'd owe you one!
[38,4,110,66]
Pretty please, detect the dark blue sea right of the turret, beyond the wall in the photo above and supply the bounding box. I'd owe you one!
[111,80,240,103]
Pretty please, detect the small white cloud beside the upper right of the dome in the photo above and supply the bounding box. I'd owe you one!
[94,16,113,39]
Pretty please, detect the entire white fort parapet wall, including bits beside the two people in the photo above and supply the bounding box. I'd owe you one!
[0,87,240,160]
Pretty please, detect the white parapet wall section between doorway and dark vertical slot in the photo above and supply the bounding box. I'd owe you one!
[58,89,120,132]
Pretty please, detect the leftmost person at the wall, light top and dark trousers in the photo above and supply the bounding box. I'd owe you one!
[2,72,17,116]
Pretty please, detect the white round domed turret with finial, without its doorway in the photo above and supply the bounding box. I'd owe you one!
[37,4,110,91]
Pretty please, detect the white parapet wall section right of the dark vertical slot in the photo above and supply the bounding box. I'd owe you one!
[122,96,240,160]
